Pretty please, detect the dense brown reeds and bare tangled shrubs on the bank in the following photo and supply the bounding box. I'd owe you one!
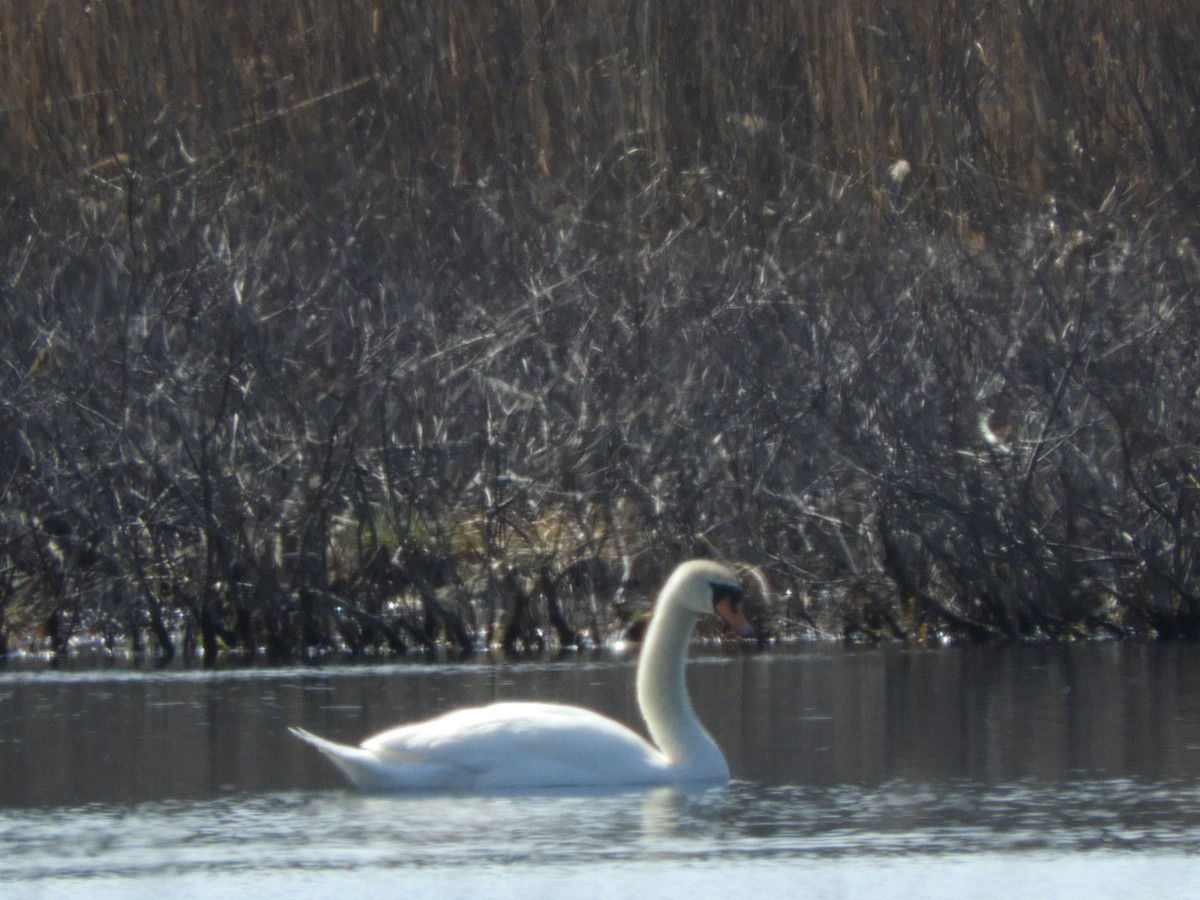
[0,0,1200,659]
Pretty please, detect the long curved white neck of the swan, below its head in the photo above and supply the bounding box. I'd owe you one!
[637,605,726,773]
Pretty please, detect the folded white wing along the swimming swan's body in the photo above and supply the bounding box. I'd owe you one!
[361,703,667,787]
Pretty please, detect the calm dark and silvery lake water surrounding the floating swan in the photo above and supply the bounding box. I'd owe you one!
[0,643,1200,900]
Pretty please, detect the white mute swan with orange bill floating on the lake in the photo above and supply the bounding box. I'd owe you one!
[290,559,751,791]
